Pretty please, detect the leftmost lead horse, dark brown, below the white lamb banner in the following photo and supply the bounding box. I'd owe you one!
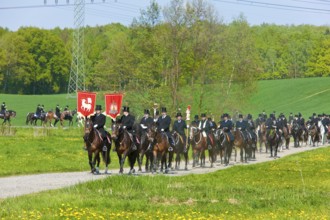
[84,119,111,174]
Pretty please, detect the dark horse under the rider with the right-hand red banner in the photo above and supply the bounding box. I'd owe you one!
[111,120,138,174]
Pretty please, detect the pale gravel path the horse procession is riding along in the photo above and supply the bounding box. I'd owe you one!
[0,145,328,199]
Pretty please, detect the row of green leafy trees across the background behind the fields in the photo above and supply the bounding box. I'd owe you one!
[0,0,330,112]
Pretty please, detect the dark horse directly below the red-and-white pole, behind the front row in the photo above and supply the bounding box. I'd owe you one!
[173,131,188,170]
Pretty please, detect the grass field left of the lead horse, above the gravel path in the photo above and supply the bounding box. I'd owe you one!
[0,127,127,177]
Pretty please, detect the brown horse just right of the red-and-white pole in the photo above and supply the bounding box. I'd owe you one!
[190,126,207,167]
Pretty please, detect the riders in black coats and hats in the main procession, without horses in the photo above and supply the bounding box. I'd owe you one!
[87,105,330,154]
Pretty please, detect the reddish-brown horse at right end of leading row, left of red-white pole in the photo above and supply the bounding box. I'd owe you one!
[148,124,170,173]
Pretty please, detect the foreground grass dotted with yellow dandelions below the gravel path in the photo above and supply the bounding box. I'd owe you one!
[0,147,330,219]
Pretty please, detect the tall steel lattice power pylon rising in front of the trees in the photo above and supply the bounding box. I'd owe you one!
[68,0,85,97]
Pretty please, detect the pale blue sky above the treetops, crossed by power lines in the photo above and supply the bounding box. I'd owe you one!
[0,0,330,31]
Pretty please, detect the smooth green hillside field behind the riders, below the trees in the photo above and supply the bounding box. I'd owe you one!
[0,77,330,126]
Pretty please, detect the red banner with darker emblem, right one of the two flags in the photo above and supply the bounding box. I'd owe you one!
[104,94,123,120]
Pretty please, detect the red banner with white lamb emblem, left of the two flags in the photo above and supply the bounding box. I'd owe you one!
[77,92,96,117]
